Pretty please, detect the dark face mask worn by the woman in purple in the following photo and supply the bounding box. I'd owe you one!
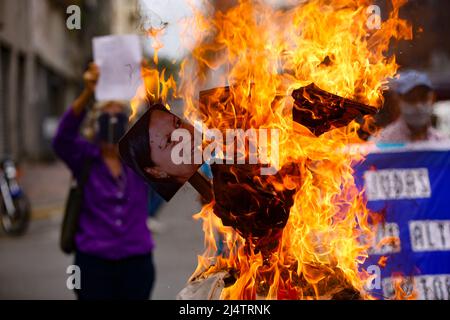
[97,113,128,144]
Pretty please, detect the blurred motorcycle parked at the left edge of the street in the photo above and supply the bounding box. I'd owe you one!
[0,159,31,236]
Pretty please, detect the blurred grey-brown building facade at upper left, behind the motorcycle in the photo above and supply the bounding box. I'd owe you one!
[0,0,137,160]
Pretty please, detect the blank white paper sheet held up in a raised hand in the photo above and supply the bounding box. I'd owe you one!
[93,35,142,101]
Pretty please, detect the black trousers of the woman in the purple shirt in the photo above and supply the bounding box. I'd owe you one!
[75,252,155,300]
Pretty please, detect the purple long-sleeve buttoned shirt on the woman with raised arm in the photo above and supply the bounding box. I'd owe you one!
[53,108,154,260]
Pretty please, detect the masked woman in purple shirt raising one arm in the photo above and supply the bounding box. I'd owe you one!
[53,64,155,300]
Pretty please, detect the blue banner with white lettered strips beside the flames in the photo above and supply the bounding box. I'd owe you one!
[355,143,450,300]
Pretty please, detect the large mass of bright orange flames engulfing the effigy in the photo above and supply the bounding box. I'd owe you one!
[176,0,411,299]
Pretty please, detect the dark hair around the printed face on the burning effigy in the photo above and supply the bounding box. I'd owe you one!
[119,104,182,200]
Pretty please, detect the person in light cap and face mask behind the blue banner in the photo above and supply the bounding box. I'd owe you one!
[374,70,445,143]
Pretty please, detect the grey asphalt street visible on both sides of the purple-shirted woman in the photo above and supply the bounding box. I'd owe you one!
[0,182,203,300]
